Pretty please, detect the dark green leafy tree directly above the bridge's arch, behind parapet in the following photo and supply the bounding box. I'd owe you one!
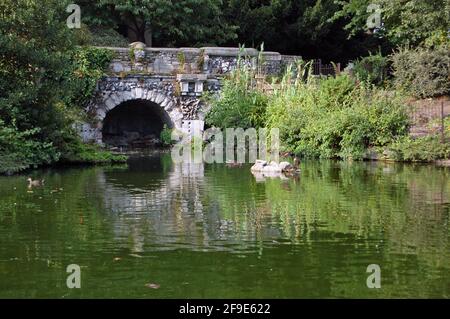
[93,0,236,46]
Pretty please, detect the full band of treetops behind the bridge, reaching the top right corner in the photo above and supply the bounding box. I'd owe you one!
[68,0,450,62]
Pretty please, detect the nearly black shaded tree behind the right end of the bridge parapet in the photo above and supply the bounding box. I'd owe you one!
[225,0,377,62]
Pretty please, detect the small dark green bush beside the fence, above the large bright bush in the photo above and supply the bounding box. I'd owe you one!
[354,53,389,85]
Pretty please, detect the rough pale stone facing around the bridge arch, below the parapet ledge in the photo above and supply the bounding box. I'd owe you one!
[84,74,216,144]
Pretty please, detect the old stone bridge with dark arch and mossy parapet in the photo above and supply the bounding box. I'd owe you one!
[79,43,299,147]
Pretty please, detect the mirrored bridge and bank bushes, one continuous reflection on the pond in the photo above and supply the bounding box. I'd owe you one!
[92,159,449,260]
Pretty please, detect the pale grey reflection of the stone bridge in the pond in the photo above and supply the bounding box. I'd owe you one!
[97,158,210,252]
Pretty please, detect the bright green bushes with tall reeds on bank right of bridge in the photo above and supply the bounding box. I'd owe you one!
[207,64,409,159]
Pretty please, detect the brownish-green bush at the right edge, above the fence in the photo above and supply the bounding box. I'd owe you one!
[392,47,450,98]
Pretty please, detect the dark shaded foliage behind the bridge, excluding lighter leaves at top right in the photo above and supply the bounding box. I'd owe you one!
[73,0,376,61]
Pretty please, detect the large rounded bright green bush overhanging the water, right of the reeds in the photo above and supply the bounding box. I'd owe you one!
[267,75,408,159]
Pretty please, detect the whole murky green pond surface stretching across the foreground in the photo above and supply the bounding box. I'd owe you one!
[0,154,450,298]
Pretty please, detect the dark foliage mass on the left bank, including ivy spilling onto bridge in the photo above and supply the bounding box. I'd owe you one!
[0,0,124,173]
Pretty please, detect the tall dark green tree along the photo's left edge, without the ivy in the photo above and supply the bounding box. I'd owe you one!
[0,0,73,168]
